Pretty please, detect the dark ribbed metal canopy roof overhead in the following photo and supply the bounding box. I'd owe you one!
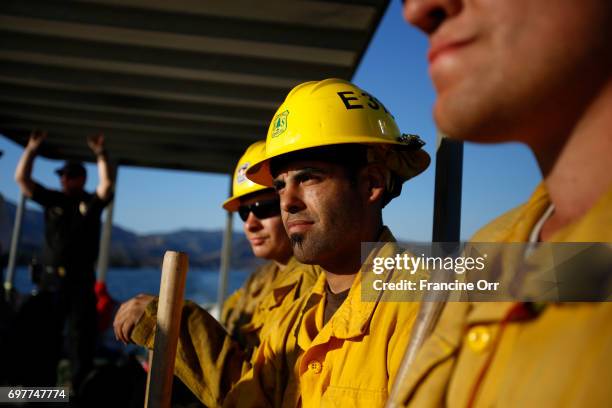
[0,0,389,173]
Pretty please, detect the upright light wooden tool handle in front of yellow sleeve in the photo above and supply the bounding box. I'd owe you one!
[145,251,189,408]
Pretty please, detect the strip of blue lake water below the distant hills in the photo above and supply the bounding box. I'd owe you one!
[7,266,252,304]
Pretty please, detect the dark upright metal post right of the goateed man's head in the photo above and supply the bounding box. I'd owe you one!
[432,134,463,242]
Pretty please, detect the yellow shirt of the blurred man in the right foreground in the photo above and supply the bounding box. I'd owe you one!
[392,184,612,408]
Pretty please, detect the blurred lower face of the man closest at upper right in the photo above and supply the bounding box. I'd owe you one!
[404,0,612,144]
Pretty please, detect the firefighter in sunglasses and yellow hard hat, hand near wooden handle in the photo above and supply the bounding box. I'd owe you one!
[114,141,320,407]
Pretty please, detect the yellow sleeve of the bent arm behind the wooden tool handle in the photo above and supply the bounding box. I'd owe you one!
[132,299,248,407]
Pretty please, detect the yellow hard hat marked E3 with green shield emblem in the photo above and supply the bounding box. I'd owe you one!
[247,79,430,186]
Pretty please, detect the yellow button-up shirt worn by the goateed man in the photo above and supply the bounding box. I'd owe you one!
[224,228,418,408]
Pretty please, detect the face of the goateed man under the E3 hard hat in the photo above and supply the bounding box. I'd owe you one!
[274,160,364,267]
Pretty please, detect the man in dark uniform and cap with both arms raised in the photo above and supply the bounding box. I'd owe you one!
[15,131,113,391]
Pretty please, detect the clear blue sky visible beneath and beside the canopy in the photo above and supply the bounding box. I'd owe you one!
[0,0,541,241]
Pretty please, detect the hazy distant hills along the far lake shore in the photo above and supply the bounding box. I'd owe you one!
[0,197,258,268]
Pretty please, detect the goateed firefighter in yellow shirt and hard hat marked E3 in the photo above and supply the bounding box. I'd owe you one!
[224,79,430,407]
